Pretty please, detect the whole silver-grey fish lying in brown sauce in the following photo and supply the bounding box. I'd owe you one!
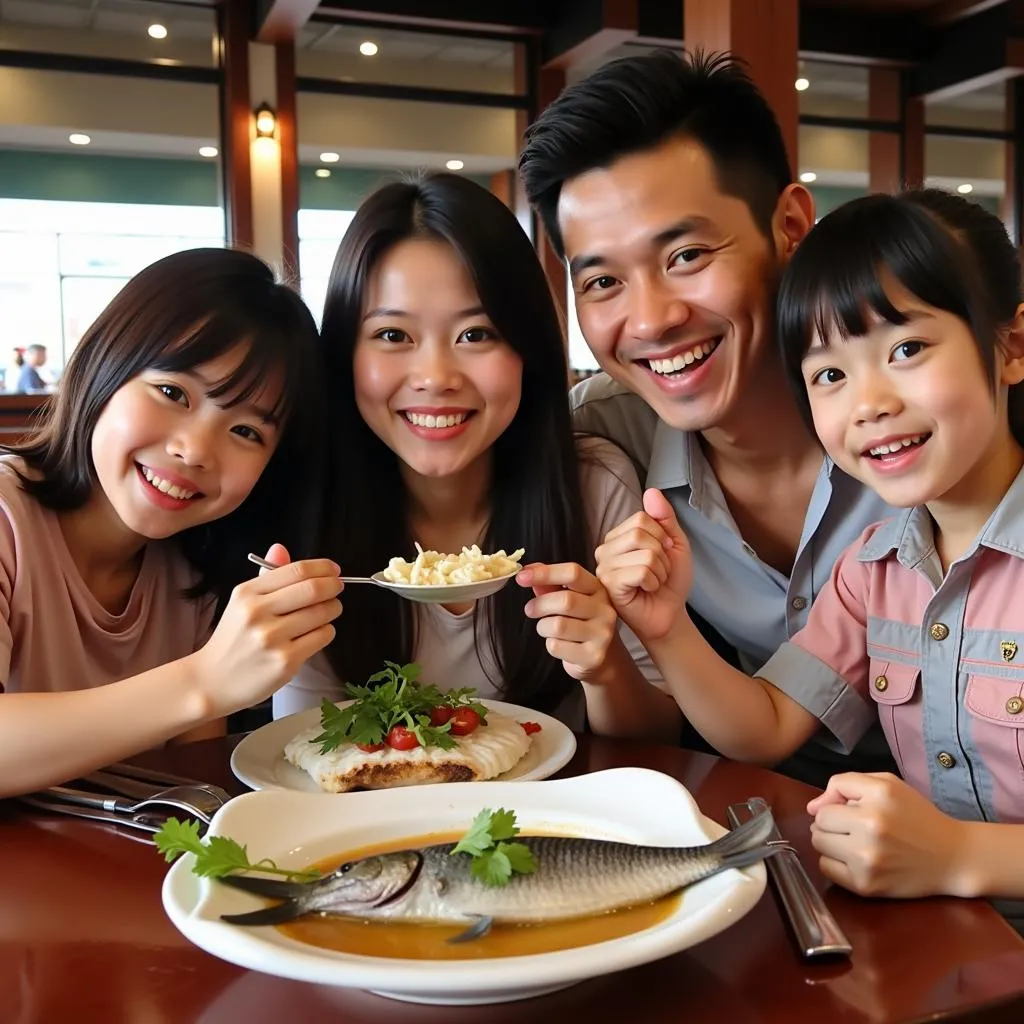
[220,811,791,939]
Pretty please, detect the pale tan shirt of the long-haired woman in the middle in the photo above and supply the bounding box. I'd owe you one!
[273,437,664,729]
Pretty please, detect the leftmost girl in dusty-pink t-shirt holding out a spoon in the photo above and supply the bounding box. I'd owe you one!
[0,249,341,797]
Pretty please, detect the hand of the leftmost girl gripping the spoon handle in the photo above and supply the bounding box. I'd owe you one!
[190,544,344,717]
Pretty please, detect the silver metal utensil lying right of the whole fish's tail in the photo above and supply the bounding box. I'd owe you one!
[727,797,853,958]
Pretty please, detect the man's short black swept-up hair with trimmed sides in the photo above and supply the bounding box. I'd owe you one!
[519,49,793,256]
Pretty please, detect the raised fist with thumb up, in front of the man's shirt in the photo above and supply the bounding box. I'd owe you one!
[596,488,693,643]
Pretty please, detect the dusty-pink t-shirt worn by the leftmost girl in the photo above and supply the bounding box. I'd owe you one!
[0,457,210,693]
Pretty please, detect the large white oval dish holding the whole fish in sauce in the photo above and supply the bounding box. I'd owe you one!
[163,768,765,1005]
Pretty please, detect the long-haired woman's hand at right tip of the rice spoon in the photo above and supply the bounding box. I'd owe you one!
[515,562,618,682]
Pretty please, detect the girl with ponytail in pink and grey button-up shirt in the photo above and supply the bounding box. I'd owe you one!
[598,186,1024,926]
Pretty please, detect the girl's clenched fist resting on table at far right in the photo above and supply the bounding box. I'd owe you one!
[807,772,967,898]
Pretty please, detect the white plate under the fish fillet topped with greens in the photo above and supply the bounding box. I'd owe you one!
[231,700,575,796]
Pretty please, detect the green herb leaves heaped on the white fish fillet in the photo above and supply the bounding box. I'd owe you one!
[312,662,487,754]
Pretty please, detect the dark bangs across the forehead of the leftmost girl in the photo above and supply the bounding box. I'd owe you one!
[153,316,301,422]
